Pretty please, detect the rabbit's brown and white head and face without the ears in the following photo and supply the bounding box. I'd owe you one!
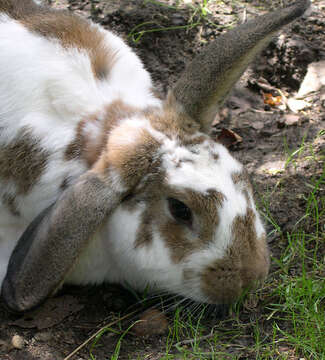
[85,108,269,303]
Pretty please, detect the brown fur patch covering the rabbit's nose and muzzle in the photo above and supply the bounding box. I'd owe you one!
[202,209,269,303]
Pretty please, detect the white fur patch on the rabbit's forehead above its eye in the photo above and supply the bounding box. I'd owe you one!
[162,139,243,195]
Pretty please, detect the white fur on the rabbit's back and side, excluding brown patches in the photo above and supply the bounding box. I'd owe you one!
[0,14,160,284]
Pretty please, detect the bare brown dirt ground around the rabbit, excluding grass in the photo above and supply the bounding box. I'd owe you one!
[0,0,325,360]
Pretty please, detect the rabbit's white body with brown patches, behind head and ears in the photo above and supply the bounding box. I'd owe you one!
[0,0,159,284]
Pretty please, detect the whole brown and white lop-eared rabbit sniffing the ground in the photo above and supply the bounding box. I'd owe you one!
[0,0,309,312]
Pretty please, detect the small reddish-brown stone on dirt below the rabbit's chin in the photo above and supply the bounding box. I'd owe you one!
[132,309,168,337]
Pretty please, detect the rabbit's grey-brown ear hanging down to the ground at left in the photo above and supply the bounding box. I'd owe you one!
[2,171,126,312]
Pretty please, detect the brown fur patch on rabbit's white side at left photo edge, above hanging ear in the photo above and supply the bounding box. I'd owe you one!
[0,128,49,194]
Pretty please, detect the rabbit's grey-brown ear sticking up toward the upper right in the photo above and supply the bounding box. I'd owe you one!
[167,0,309,132]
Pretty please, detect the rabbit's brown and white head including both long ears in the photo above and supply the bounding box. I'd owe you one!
[2,0,308,311]
